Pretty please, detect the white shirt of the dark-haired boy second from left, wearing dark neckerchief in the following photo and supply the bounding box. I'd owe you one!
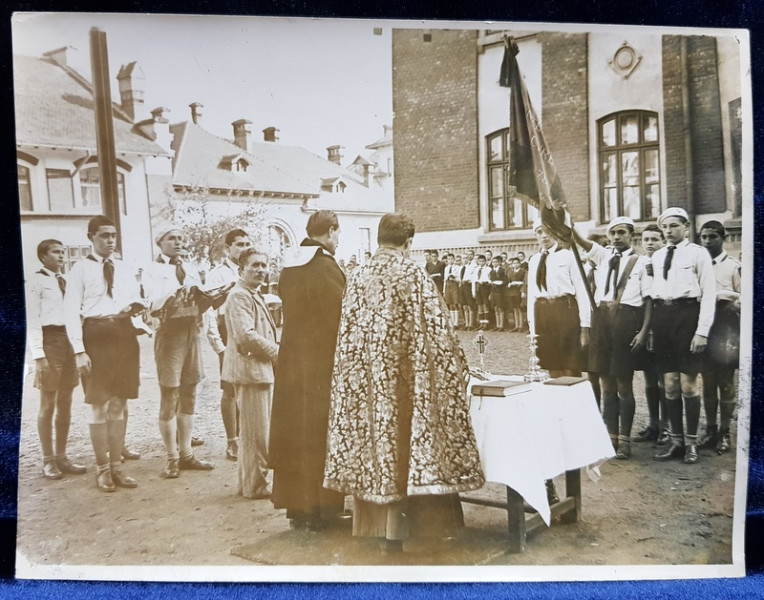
[64,254,141,354]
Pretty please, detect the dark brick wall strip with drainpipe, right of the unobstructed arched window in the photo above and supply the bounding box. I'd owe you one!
[663,35,727,213]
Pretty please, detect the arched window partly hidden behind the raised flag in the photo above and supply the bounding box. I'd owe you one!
[486,128,538,231]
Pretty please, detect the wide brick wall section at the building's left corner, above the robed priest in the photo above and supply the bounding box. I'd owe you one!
[393,29,480,231]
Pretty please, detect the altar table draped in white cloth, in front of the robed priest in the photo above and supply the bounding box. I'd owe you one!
[461,377,615,552]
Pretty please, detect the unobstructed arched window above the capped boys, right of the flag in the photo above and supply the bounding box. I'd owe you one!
[597,110,661,223]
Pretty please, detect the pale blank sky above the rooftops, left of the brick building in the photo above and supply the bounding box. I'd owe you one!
[13,13,392,164]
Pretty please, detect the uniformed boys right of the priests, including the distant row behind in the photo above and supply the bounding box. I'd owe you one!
[425,207,740,464]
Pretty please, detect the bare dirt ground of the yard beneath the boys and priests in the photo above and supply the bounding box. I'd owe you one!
[11,332,742,579]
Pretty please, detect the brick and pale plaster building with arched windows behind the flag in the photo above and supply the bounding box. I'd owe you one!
[393,29,742,253]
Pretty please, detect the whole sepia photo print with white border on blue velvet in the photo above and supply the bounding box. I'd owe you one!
[12,12,753,582]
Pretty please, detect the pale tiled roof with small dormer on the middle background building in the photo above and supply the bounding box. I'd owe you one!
[170,121,368,197]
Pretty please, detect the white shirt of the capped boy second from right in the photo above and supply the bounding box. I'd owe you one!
[651,240,716,337]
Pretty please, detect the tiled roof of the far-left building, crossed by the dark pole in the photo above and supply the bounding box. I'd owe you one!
[13,56,167,156]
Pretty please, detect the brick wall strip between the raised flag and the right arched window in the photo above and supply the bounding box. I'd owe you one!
[534,33,591,220]
